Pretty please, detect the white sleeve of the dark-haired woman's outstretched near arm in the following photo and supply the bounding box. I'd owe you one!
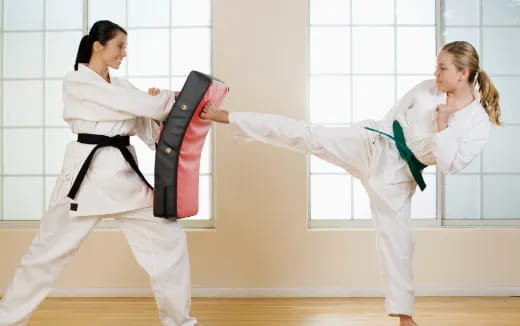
[68,76,175,121]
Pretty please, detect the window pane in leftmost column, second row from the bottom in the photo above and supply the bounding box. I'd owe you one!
[4,128,43,174]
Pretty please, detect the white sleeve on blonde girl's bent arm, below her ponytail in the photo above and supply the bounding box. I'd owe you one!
[432,116,491,174]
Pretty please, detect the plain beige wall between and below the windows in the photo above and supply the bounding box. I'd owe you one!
[0,0,520,295]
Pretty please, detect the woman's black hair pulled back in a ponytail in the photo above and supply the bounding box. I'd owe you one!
[74,20,128,70]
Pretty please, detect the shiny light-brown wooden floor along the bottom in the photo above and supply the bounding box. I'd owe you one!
[29,297,520,326]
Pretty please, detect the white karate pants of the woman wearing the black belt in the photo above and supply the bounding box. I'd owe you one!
[0,200,196,326]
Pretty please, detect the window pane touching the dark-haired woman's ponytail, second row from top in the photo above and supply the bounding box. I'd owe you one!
[45,32,82,78]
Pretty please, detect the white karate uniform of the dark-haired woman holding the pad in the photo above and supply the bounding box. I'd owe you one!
[0,64,196,326]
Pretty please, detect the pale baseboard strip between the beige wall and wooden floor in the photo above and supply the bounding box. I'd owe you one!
[0,286,520,298]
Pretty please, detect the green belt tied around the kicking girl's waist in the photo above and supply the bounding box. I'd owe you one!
[365,120,426,191]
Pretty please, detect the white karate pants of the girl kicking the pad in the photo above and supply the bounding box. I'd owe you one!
[230,112,416,316]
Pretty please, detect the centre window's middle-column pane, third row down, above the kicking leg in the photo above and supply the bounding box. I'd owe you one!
[352,76,395,121]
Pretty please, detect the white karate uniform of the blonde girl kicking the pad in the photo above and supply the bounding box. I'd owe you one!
[229,80,490,315]
